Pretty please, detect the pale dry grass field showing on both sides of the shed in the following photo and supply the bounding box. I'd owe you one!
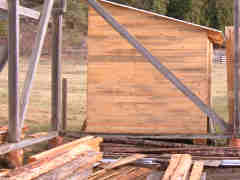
[0,57,228,135]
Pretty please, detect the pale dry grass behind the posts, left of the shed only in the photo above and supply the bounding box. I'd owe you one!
[0,57,86,132]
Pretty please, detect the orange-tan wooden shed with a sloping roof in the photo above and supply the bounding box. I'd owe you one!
[85,0,223,134]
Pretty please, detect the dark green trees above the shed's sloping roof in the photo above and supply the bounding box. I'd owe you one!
[111,0,234,31]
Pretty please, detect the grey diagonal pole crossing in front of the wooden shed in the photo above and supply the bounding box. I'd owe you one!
[87,0,228,131]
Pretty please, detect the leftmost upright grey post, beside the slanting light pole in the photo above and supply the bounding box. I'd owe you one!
[8,0,21,142]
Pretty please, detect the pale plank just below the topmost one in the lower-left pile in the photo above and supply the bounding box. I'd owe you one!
[8,145,99,180]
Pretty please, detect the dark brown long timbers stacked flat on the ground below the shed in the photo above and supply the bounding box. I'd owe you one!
[101,137,240,159]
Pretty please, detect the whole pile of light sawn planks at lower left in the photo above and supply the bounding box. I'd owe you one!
[0,136,102,180]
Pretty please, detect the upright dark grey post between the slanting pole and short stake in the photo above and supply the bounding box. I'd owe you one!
[51,0,63,131]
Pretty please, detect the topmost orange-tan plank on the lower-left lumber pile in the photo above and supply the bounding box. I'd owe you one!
[28,136,103,162]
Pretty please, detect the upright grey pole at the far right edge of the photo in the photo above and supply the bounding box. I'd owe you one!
[233,0,239,135]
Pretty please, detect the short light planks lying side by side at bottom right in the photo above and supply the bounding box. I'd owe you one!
[162,154,204,180]
